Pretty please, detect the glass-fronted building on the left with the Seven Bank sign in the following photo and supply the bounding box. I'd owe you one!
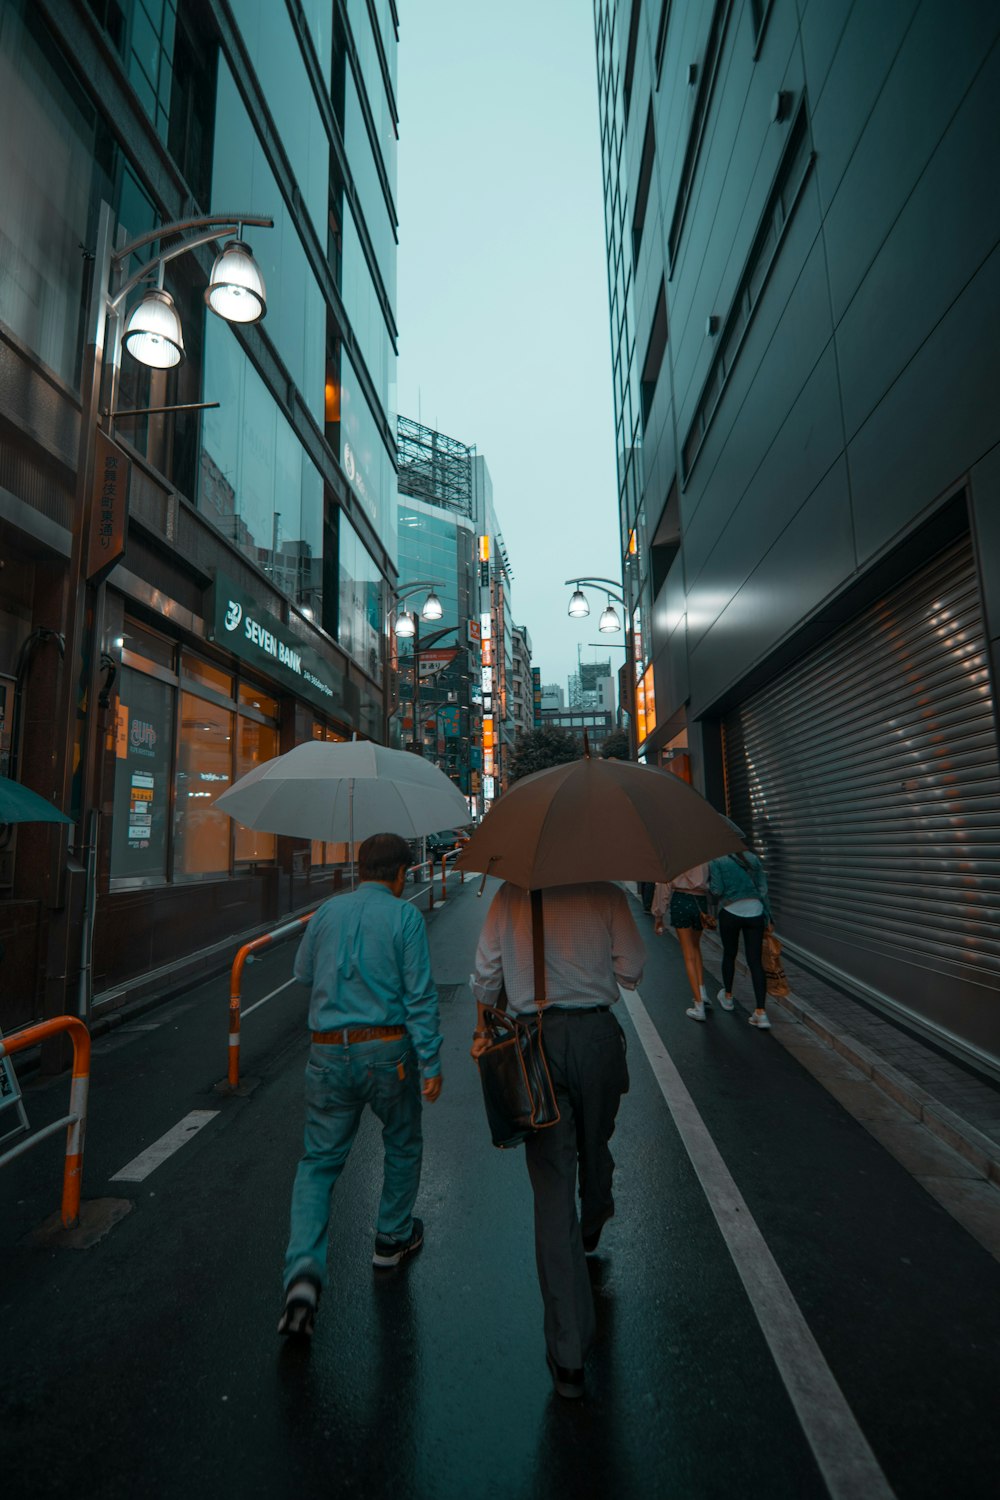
[0,0,397,1026]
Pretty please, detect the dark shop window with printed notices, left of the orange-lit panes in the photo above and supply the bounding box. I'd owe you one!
[111,666,174,884]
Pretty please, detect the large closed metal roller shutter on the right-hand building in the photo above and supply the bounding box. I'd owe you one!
[724,537,1000,1059]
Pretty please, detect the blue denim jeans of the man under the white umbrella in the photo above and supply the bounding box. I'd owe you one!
[285,1037,423,1289]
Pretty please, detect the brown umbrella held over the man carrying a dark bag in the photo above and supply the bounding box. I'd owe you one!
[457,756,745,891]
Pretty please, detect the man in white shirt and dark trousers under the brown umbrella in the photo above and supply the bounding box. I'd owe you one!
[472,882,646,1398]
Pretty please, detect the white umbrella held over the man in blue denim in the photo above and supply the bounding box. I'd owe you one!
[216,740,469,845]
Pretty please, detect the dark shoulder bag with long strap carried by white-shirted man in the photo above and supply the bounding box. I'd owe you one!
[477,891,559,1151]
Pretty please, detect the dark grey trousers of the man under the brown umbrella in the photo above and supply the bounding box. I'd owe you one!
[525,1010,628,1370]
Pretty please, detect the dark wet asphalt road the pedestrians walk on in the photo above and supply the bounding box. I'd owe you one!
[0,884,1000,1500]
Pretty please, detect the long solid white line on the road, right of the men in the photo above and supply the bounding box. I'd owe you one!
[621,990,892,1500]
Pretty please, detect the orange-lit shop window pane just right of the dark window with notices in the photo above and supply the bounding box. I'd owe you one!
[174,693,234,879]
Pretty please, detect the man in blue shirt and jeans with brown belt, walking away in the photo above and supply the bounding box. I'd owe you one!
[277,834,441,1337]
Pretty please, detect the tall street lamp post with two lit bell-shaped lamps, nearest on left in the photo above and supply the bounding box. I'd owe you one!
[60,203,274,1016]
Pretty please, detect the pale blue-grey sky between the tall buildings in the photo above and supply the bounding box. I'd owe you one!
[397,0,624,687]
